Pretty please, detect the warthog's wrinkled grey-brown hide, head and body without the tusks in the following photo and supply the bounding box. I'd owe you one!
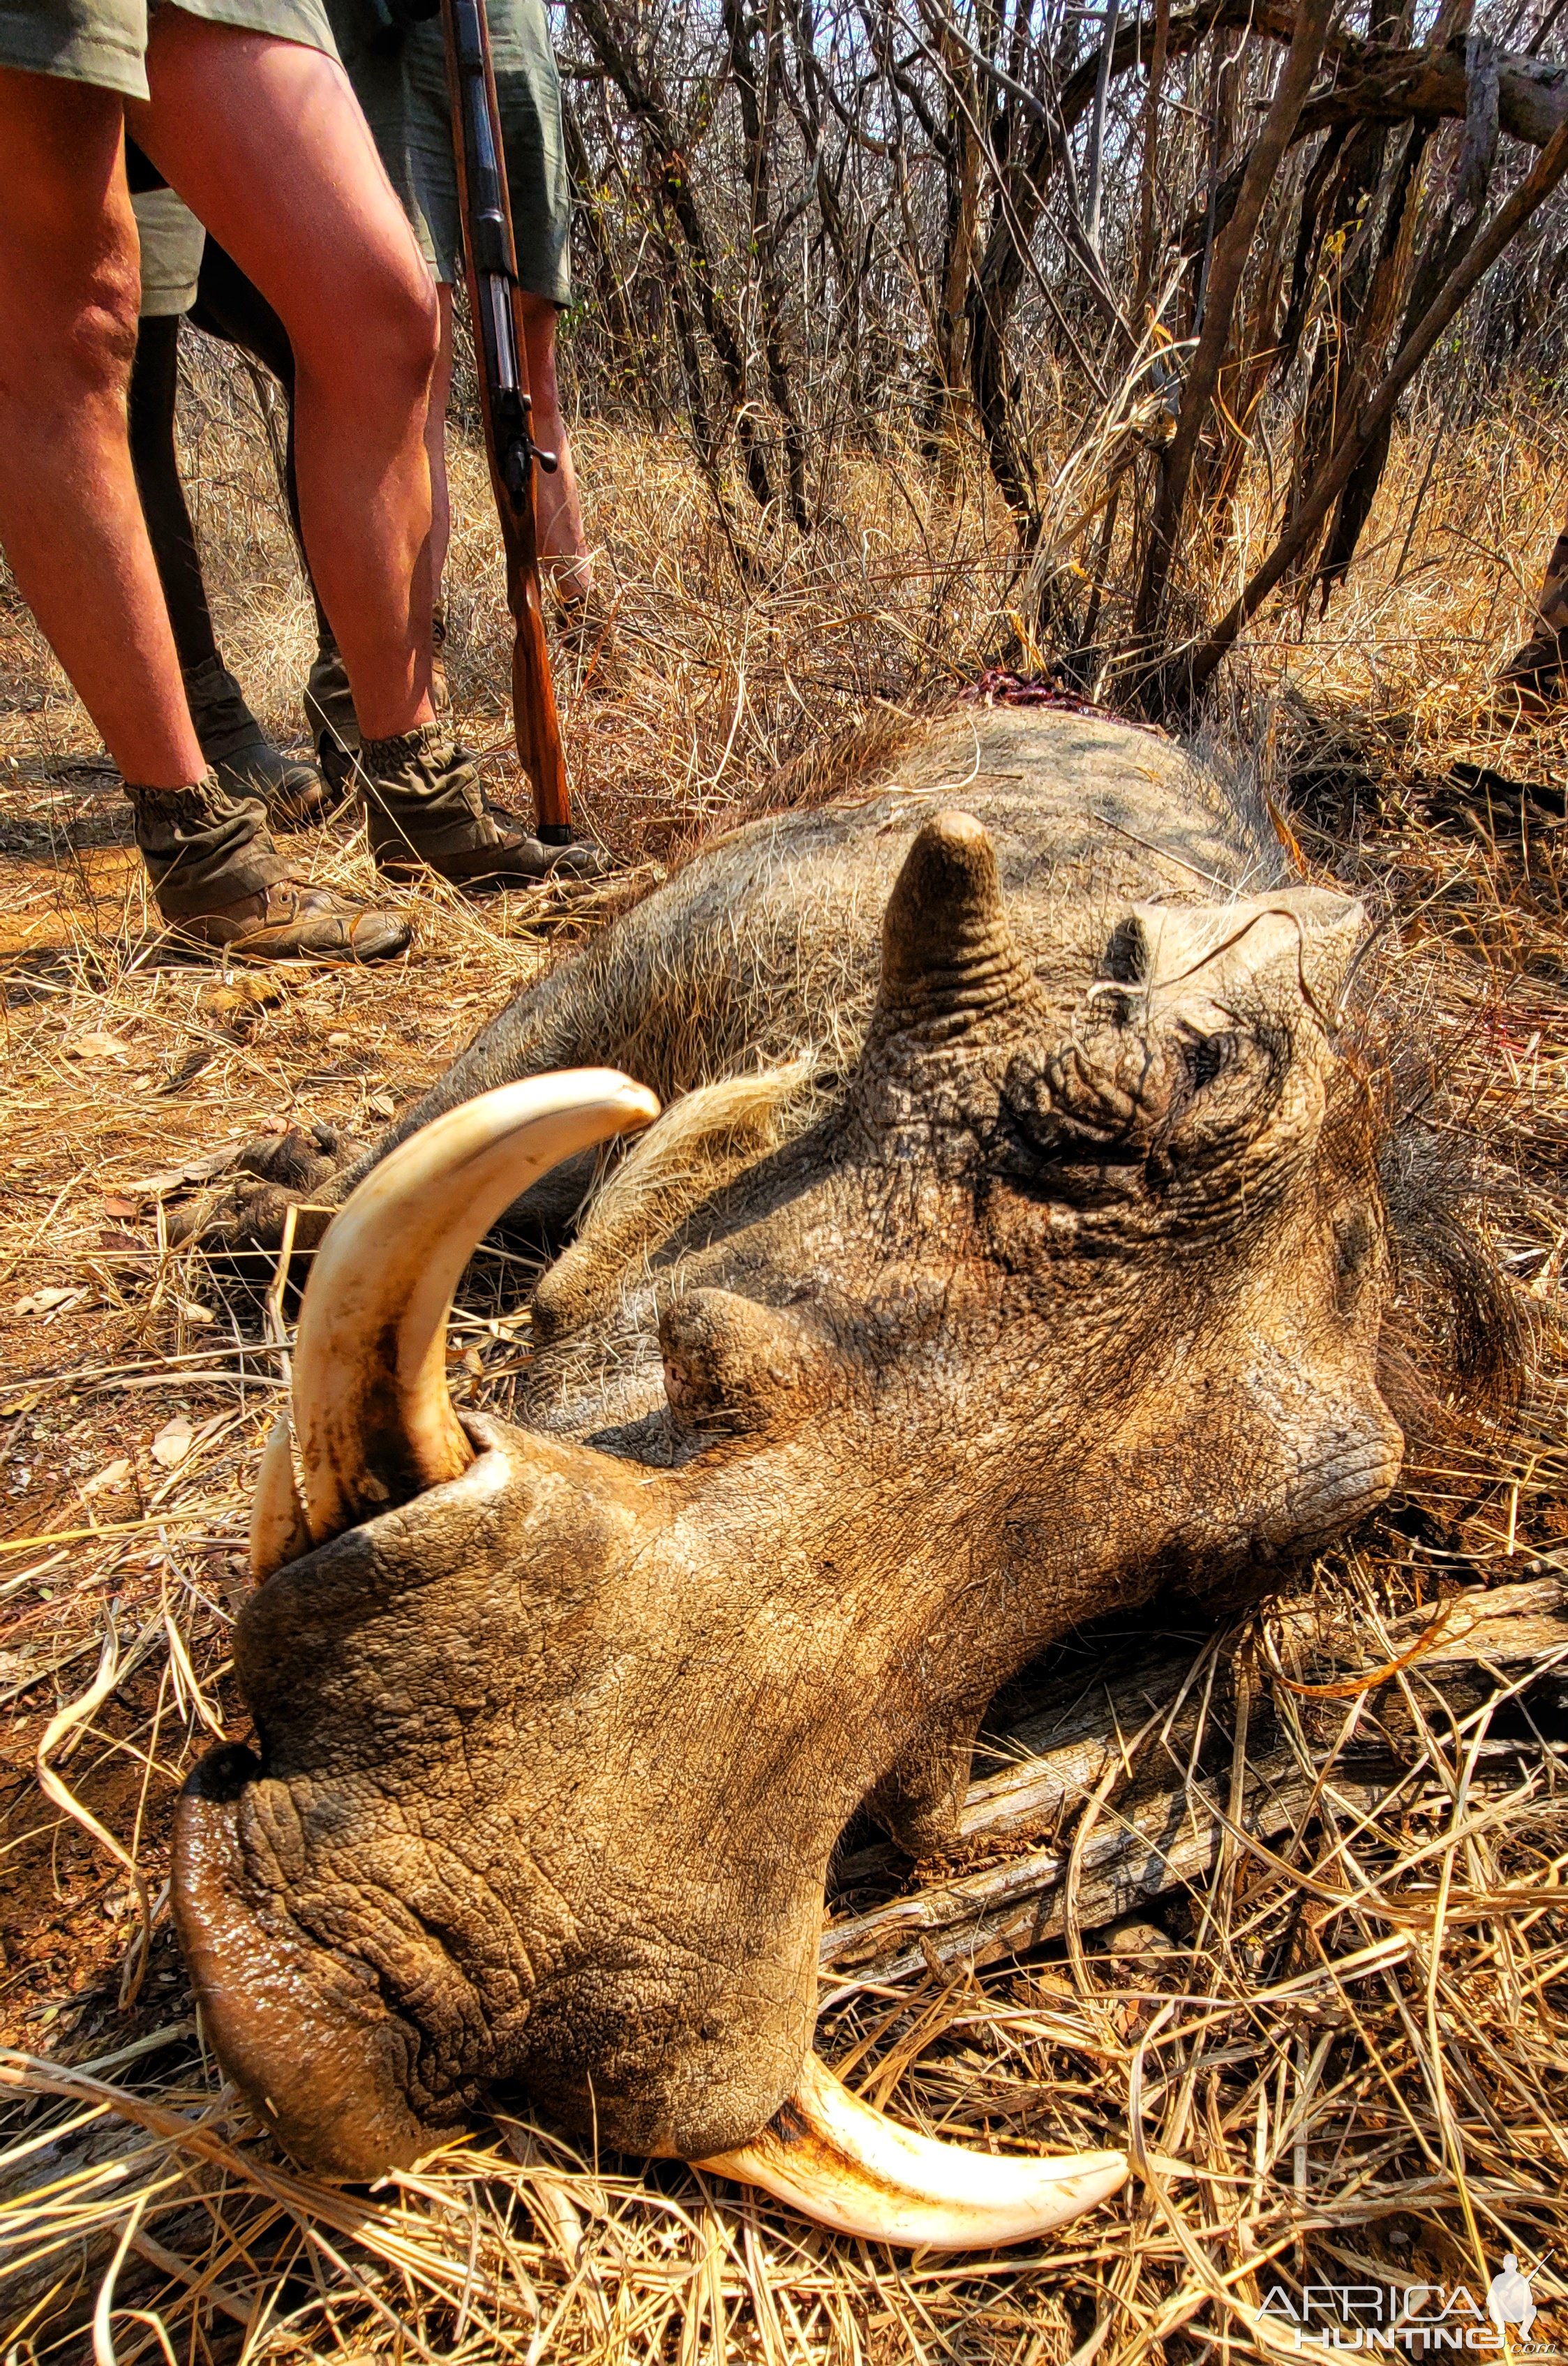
[175,710,1400,2174]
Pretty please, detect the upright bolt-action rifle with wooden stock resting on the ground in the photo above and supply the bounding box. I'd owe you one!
[440,0,577,845]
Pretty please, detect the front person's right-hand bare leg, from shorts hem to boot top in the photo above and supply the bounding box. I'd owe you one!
[128,7,438,738]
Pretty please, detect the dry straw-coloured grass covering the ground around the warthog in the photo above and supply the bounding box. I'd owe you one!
[0,350,1568,2366]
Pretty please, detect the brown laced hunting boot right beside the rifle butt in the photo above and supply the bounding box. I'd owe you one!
[359,724,613,887]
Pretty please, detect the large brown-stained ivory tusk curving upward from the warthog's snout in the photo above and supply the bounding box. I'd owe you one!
[293,1067,660,1545]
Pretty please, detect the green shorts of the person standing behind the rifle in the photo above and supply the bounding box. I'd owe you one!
[326,0,572,305]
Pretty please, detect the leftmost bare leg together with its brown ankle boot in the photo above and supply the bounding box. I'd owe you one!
[0,66,409,960]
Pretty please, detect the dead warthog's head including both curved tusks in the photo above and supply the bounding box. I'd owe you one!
[175,814,1400,2243]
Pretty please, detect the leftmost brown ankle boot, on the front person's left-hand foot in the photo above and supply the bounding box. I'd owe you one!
[126,774,409,960]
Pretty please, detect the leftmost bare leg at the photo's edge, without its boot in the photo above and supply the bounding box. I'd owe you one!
[0,66,206,788]
